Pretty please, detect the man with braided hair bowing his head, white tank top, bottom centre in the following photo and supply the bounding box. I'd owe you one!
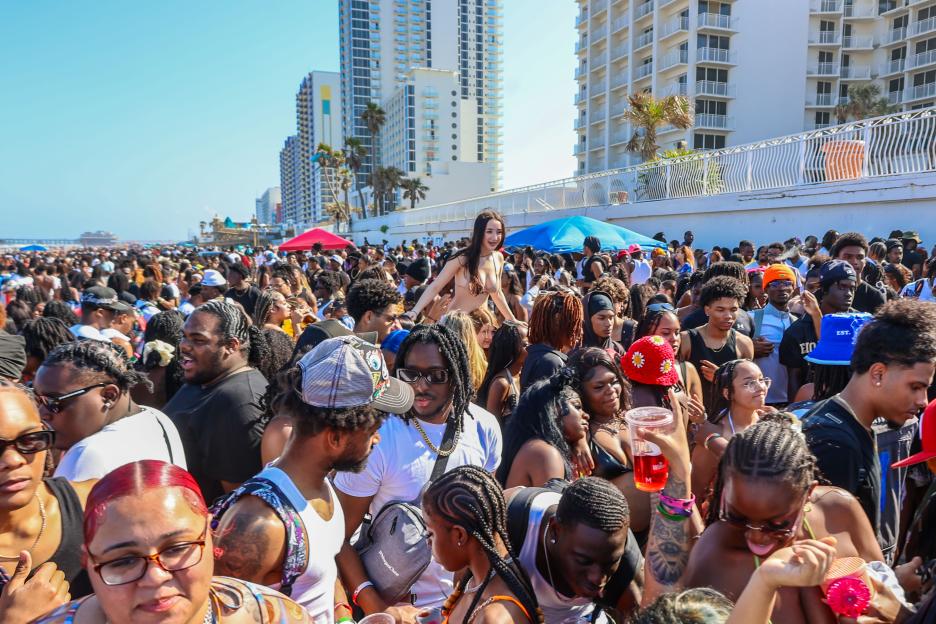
[506,477,643,624]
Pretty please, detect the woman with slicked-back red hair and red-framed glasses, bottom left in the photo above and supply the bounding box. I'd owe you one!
[39,461,310,624]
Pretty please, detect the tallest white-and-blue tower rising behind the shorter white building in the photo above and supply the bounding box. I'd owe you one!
[339,0,503,192]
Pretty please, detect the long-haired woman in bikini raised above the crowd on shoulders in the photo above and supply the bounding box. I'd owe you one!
[406,210,517,321]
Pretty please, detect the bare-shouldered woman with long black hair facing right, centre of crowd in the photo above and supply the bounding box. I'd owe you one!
[497,368,589,488]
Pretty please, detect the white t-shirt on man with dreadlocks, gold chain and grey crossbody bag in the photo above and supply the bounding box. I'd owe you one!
[334,405,502,607]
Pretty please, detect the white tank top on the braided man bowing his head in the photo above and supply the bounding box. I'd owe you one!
[519,492,606,624]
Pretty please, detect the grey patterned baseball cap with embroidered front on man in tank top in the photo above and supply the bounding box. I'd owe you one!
[299,336,414,414]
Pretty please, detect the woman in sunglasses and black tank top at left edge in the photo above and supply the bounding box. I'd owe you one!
[0,380,93,624]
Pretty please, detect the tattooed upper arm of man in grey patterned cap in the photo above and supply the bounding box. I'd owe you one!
[215,514,270,583]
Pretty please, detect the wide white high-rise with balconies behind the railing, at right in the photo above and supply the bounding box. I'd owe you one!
[573,0,936,173]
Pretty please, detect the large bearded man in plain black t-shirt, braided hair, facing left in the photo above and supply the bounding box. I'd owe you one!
[163,299,270,501]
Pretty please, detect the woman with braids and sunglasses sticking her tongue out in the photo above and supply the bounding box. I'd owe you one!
[684,417,883,624]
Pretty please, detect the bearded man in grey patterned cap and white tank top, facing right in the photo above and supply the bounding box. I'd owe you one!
[215,336,413,624]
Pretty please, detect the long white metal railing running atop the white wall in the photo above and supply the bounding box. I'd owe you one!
[355,107,936,231]
